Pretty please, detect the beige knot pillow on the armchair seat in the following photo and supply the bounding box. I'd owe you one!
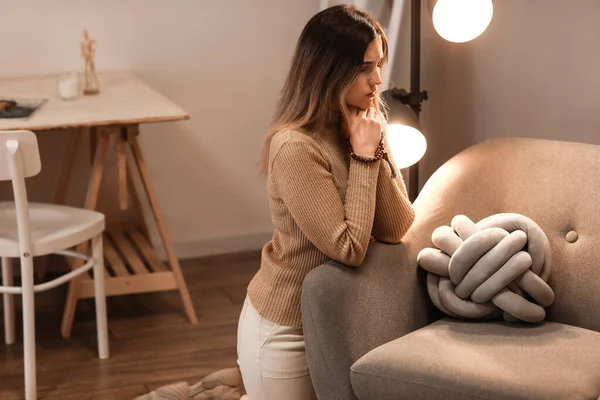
[417,213,554,323]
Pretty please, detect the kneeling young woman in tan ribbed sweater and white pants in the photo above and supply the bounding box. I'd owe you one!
[238,5,414,400]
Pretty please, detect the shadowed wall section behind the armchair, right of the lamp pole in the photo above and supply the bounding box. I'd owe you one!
[420,0,600,188]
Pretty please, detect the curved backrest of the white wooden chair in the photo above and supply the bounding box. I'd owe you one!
[0,131,42,181]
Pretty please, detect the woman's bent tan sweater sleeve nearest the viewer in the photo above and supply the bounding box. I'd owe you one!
[270,140,381,266]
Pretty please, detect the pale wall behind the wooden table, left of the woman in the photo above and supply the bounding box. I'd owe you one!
[0,0,319,257]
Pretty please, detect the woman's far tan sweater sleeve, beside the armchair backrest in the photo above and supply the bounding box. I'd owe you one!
[373,140,415,244]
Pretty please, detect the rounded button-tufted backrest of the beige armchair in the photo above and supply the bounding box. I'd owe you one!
[406,138,600,331]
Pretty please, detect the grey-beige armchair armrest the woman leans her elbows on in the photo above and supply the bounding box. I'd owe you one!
[302,242,438,400]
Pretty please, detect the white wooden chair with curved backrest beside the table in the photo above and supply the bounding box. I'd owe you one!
[0,131,109,400]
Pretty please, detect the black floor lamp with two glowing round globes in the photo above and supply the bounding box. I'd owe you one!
[382,0,493,201]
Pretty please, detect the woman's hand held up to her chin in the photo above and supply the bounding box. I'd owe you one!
[348,107,381,157]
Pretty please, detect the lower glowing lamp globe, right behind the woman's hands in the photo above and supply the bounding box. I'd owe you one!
[387,124,427,169]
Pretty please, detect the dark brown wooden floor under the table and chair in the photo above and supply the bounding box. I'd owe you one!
[0,252,260,400]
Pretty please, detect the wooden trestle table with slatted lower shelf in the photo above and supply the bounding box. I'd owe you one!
[0,72,197,337]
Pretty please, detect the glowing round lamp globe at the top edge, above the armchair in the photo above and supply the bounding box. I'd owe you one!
[431,0,494,43]
